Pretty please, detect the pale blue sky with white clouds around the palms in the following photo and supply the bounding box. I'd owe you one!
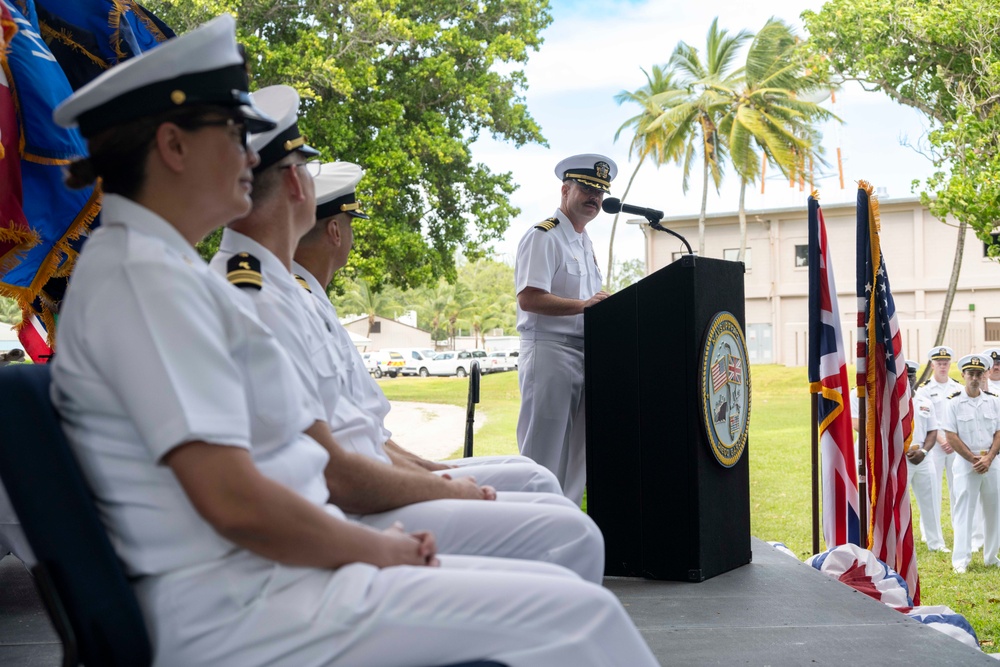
[472,0,932,270]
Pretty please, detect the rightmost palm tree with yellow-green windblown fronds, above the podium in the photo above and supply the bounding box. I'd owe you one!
[713,18,835,261]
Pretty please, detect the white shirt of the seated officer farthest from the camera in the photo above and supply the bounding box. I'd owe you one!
[292,263,392,463]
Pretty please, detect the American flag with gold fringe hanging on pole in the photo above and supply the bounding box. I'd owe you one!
[857,181,920,604]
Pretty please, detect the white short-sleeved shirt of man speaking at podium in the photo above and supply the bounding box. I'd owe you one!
[514,210,603,336]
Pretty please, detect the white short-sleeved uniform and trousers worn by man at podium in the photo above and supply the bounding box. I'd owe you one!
[514,210,602,504]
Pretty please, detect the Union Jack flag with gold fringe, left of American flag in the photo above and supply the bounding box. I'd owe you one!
[809,193,861,549]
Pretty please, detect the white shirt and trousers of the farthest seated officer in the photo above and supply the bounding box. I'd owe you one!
[292,262,562,494]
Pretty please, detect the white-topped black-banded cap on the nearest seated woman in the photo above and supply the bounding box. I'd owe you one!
[52,14,274,139]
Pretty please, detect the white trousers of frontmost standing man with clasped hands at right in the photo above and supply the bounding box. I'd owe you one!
[951,456,1000,567]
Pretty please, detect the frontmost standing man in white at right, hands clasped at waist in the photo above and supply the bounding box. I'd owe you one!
[941,354,1000,573]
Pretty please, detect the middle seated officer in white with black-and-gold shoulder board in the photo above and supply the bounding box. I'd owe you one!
[210,91,604,583]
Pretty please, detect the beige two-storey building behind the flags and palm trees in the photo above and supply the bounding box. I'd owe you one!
[629,195,1000,366]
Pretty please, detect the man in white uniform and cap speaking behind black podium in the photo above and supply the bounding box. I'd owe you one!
[514,153,618,504]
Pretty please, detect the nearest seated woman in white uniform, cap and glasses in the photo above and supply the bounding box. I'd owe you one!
[52,16,656,667]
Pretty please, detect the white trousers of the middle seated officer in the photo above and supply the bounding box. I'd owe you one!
[351,493,604,584]
